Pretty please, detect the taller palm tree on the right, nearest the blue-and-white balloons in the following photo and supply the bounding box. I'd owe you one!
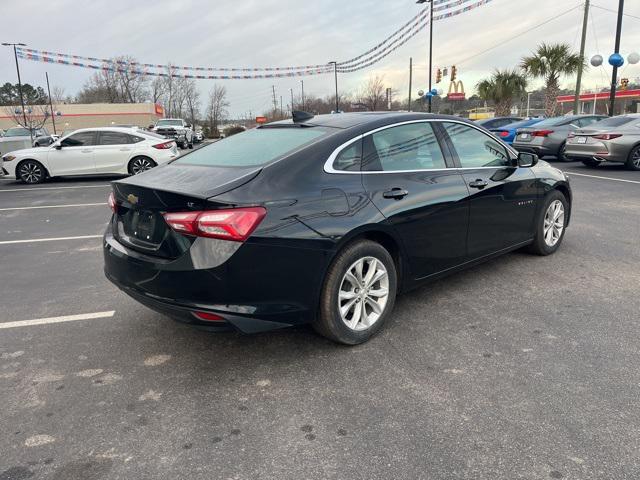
[520,43,586,117]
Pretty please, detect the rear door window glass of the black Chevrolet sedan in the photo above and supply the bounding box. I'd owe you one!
[362,122,447,172]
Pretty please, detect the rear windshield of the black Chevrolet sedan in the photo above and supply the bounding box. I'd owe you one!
[174,127,328,167]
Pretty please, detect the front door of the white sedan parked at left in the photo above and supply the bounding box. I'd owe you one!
[47,130,96,176]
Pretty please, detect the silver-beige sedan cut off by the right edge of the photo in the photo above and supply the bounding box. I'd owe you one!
[566,113,640,170]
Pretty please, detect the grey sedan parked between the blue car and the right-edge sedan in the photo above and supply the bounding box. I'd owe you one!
[513,115,608,161]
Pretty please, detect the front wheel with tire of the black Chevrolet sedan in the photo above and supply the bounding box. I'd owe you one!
[529,190,569,255]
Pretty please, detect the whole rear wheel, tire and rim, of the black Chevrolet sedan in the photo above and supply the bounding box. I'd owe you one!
[313,240,398,345]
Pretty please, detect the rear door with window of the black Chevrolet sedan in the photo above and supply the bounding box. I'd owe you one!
[362,121,469,279]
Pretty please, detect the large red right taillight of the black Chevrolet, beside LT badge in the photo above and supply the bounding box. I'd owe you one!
[164,207,267,242]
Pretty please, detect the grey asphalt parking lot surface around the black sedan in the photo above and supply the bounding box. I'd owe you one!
[0,163,640,480]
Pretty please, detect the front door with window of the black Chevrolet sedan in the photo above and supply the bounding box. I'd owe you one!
[442,121,537,259]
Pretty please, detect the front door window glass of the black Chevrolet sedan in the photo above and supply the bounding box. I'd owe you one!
[442,122,511,168]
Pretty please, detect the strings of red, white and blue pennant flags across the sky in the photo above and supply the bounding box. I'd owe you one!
[16,0,492,80]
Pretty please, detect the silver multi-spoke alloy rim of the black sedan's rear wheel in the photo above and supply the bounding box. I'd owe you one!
[338,257,389,331]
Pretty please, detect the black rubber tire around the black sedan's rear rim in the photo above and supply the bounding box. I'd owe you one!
[313,240,398,345]
